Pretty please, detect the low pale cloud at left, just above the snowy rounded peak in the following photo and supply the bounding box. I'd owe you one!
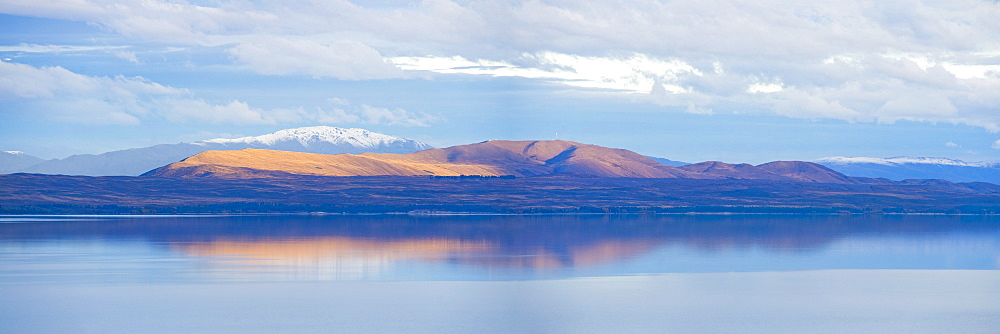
[0,61,438,126]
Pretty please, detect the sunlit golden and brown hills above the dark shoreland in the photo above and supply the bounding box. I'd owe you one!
[145,140,698,178]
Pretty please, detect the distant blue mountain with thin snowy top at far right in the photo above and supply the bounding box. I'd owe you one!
[815,157,1000,184]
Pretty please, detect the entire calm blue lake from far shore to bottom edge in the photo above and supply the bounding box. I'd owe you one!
[0,215,1000,333]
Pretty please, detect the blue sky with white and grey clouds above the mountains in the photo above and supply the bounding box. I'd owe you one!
[0,0,1000,163]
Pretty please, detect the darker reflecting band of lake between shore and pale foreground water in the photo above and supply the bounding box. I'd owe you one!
[0,215,1000,282]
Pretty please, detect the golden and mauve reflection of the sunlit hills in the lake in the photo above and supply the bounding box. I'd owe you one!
[179,237,658,279]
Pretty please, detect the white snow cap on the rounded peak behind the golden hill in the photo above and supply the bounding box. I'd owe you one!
[201,126,430,148]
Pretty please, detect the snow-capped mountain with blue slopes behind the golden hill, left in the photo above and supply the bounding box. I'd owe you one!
[19,126,431,176]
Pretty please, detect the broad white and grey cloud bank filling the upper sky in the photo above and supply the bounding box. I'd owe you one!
[0,0,1000,132]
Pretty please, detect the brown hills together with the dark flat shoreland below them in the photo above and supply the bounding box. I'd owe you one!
[0,140,1000,214]
